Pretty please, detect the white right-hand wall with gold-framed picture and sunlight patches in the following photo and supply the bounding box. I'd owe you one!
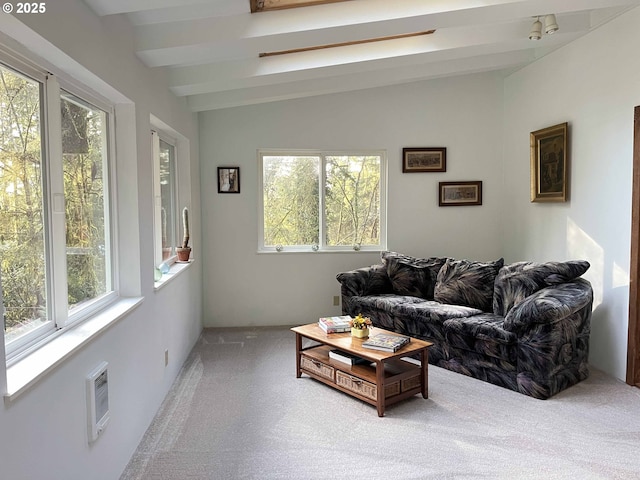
[504,9,640,379]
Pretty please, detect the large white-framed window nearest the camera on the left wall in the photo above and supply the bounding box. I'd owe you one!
[0,57,115,356]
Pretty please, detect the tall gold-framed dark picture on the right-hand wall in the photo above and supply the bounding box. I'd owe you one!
[529,122,569,202]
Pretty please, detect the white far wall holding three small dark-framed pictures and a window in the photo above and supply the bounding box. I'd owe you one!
[199,74,502,326]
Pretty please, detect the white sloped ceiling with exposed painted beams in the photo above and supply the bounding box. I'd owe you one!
[84,0,640,111]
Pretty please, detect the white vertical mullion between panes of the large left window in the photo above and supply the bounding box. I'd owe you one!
[45,75,69,328]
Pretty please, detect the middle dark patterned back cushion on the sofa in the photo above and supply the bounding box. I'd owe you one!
[434,258,504,312]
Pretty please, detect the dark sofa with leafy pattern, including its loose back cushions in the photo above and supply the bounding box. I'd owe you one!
[337,252,593,399]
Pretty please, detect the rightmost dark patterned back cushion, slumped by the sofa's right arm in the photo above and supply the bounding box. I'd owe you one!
[493,260,590,317]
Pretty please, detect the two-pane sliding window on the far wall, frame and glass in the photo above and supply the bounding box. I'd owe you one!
[258,150,386,252]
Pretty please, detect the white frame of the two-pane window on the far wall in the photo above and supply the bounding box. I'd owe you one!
[257,149,387,253]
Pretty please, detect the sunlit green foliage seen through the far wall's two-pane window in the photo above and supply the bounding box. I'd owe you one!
[263,155,380,246]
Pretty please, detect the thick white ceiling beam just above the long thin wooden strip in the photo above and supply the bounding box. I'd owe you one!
[135,0,603,66]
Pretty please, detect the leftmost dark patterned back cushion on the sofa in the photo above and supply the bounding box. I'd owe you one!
[380,252,447,300]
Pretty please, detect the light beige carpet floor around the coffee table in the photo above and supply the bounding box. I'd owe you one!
[121,328,640,480]
